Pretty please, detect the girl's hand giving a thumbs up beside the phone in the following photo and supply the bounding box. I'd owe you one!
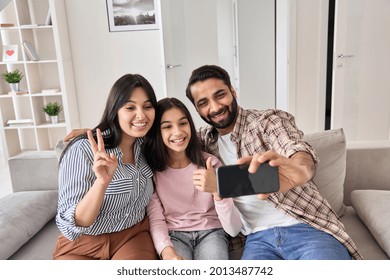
[192,157,221,200]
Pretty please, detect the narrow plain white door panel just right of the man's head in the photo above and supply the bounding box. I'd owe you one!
[236,0,276,109]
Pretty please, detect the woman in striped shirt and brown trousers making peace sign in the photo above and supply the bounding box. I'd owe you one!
[53,74,157,260]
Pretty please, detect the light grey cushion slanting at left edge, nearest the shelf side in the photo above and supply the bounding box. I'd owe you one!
[0,190,58,259]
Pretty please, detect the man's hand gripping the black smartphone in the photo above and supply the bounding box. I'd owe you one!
[237,151,315,199]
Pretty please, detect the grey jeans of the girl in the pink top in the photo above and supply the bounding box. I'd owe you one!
[169,229,229,260]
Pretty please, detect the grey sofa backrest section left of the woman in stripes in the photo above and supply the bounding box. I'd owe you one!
[8,151,58,192]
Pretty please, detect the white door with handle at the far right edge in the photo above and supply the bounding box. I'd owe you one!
[331,0,390,141]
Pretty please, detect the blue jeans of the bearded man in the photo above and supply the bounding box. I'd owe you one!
[241,223,351,260]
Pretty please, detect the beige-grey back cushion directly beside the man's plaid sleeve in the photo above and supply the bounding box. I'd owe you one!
[304,128,347,216]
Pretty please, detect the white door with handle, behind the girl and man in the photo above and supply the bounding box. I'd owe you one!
[161,0,233,129]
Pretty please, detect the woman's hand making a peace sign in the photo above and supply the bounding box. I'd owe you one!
[87,129,118,186]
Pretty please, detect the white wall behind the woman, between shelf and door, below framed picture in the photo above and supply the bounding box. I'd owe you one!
[65,0,163,127]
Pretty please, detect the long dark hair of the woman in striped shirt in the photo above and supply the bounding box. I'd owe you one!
[60,74,157,162]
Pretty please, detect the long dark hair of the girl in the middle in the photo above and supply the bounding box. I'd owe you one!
[144,97,206,171]
